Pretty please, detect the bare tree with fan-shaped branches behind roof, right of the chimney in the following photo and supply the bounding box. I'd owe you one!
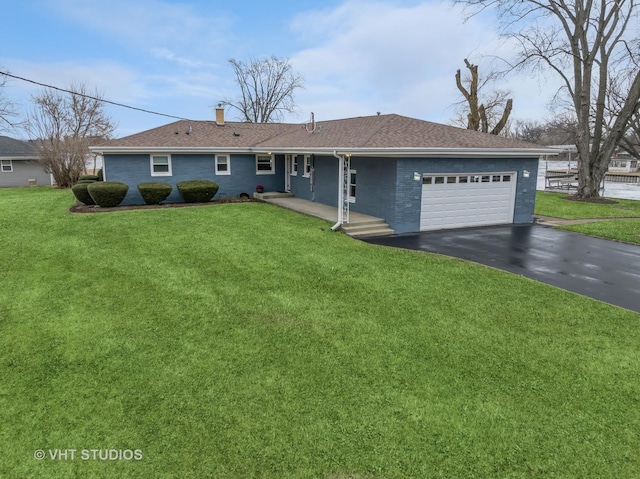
[222,56,304,123]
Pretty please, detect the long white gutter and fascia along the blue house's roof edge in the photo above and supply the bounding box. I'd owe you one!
[89,146,563,158]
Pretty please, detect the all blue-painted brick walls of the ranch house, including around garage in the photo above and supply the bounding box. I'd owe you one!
[104,152,538,233]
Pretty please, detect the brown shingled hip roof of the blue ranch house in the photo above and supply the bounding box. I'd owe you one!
[91,114,553,156]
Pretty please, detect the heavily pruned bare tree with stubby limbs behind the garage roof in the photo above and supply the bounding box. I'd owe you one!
[454,58,513,135]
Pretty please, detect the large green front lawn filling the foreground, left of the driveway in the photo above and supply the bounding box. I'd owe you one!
[0,189,640,479]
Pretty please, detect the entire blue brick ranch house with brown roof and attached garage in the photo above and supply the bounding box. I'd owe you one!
[91,109,554,233]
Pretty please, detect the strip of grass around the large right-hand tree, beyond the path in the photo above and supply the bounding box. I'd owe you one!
[536,191,640,220]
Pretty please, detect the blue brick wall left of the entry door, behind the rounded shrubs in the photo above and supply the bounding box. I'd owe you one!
[104,154,284,205]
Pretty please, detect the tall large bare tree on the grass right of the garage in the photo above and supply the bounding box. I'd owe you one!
[454,0,640,198]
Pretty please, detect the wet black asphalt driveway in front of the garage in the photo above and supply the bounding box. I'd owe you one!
[364,224,640,312]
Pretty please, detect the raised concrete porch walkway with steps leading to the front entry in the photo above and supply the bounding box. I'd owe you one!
[253,192,394,237]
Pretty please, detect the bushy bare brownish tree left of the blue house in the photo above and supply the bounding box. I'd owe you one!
[28,84,115,188]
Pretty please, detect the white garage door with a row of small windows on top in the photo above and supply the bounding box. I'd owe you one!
[420,172,516,231]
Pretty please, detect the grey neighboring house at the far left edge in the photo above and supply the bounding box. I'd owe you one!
[0,136,52,187]
